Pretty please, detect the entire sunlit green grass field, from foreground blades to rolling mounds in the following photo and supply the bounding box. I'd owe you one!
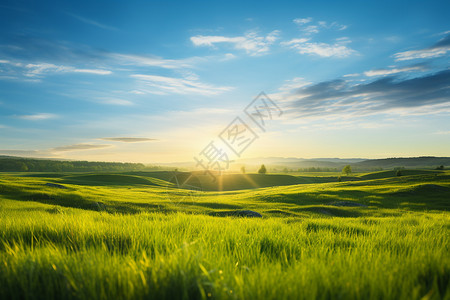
[0,170,450,299]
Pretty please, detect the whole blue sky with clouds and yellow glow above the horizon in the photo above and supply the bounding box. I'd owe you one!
[0,0,450,163]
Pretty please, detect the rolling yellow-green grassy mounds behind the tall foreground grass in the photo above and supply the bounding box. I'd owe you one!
[0,172,450,216]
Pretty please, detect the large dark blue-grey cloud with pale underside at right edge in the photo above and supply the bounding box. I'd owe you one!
[286,70,450,119]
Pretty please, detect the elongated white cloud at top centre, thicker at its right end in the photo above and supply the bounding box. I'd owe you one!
[191,30,280,55]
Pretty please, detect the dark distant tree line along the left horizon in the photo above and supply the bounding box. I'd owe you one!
[0,158,160,172]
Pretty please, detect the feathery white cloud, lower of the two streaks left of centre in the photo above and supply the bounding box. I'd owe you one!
[131,74,232,96]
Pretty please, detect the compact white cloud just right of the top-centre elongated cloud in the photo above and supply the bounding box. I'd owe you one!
[282,39,357,58]
